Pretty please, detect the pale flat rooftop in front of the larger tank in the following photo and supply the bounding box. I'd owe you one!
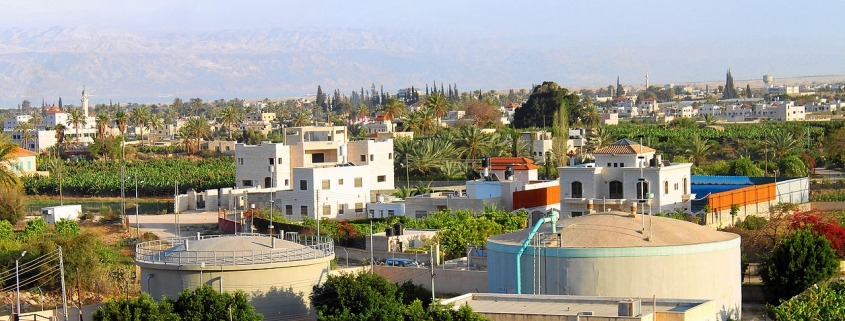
[442,293,709,317]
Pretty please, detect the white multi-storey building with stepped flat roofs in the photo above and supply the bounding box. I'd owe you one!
[235,126,394,220]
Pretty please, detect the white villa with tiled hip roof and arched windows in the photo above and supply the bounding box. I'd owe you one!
[558,139,693,216]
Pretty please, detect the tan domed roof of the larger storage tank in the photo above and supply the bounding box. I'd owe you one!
[488,212,739,248]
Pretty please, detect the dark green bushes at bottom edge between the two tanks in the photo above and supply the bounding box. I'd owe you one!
[311,273,485,321]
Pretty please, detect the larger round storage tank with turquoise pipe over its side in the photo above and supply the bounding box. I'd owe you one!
[487,212,742,320]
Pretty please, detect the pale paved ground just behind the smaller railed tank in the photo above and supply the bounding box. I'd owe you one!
[127,211,217,238]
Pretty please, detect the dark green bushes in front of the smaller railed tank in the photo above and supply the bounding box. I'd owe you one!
[94,285,263,321]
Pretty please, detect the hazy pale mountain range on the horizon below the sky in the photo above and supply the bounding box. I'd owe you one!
[0,27,840,107]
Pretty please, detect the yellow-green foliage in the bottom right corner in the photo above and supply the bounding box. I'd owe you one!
[771,280,845,321]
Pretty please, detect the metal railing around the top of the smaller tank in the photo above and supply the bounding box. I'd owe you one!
[135,233,334,266]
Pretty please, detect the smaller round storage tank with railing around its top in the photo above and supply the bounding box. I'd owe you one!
[135,234,334,320]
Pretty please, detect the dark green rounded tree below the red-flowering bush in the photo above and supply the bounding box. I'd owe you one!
[761,229,839,304]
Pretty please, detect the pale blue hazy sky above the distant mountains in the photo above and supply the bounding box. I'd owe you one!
[0,0,845,104]
